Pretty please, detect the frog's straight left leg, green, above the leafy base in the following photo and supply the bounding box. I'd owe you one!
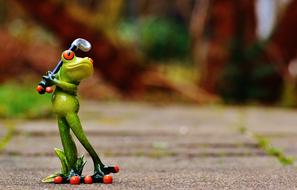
[58,116,77,173]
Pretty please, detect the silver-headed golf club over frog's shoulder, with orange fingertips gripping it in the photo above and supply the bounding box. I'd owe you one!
[36,38,92,94]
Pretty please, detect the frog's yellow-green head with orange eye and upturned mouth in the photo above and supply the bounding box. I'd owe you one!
[59,50,94,83]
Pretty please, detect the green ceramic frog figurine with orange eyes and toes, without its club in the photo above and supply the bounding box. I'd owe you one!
[43,50,119,184]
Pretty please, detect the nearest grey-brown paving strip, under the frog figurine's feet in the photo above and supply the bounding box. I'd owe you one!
[0,156,297,189]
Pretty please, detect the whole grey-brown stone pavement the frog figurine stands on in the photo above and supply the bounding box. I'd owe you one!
[0,102,297,190]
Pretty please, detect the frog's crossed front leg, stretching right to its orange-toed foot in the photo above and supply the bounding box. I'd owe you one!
[66,113,119,178]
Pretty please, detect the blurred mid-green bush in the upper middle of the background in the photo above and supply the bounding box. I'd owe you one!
[119,17,190,60]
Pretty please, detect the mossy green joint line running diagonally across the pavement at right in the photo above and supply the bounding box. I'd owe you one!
[235,109,295,166]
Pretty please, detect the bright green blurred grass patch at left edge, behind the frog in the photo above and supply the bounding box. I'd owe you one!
[0,84,51,118]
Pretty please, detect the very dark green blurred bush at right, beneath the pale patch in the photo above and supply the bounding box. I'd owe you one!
[219,39,282,103]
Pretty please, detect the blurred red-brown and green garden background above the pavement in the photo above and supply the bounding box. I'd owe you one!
[0,0,297,118]
